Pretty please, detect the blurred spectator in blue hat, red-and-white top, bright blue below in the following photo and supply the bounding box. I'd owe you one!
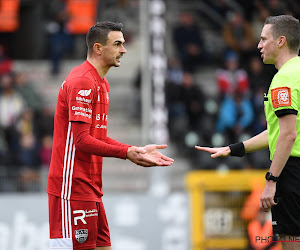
[216,51,254,142]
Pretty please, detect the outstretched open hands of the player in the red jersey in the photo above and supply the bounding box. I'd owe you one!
[127,144,174,167]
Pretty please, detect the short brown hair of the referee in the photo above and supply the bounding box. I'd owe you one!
[265,15,300,53]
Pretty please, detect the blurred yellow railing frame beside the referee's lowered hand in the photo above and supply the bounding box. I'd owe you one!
[185,170,266,250]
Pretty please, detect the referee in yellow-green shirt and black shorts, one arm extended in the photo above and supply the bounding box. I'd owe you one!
[196,15,300,250]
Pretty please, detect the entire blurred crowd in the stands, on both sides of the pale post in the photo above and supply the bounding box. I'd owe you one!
[0,0,300,192]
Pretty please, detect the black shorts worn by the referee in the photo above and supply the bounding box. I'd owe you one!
[271,157,300,236]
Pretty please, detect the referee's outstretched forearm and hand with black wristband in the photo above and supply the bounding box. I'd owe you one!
[195,130,269,158]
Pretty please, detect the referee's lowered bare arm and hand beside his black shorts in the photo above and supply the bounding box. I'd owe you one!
[259,114,297,211]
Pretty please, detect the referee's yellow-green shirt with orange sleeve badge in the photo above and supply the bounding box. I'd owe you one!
[264,57,300,160]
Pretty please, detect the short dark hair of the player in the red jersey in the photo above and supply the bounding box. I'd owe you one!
[86,21,123,53]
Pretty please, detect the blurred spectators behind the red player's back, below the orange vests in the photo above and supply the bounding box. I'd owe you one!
[0,45,53,191]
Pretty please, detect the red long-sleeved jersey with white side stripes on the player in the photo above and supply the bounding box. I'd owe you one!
[47,61,129,201]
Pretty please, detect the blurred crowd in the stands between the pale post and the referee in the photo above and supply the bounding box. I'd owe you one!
[166,0,300,169]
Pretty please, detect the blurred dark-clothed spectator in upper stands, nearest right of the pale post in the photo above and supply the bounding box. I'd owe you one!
[173,12,207,72]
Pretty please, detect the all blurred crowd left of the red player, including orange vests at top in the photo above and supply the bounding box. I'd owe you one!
[0,0,127,192]
